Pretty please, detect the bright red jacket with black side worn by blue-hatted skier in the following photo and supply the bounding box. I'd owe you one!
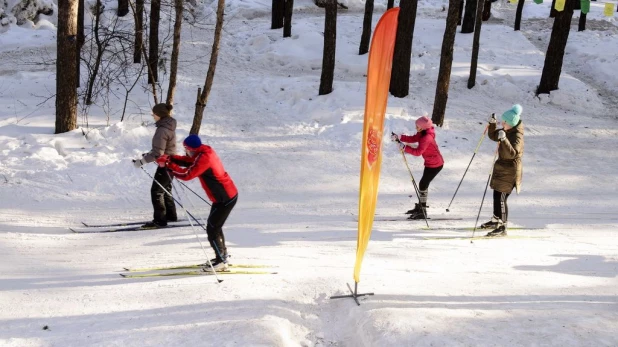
[167,145,238,203]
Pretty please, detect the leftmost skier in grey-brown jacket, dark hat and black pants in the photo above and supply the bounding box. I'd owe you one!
[133,104,178,228]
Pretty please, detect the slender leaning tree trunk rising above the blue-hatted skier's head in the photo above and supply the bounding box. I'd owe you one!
[189,0,225,135]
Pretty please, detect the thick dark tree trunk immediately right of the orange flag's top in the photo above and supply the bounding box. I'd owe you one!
[389,0,418,98]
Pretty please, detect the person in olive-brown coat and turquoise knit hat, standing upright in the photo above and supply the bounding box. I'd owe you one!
[481,104,524,237]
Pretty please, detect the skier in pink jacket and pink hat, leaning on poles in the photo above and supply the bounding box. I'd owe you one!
[391,116,444,219]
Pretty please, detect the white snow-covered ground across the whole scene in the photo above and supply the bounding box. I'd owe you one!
[0,0,618,346]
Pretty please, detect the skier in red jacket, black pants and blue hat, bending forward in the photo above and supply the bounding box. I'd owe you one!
[157,135,238,271]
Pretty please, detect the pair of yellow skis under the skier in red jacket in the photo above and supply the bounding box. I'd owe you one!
[120,264,277,278]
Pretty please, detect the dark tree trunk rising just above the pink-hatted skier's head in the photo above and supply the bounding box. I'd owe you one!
[431,0,460,126]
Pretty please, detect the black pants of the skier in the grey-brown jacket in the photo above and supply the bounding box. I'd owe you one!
[150,167,178,225]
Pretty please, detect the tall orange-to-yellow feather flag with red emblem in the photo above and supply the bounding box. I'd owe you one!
[354,7,399,283]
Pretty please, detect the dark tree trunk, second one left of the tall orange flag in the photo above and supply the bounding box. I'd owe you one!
[318,0,337,95]
